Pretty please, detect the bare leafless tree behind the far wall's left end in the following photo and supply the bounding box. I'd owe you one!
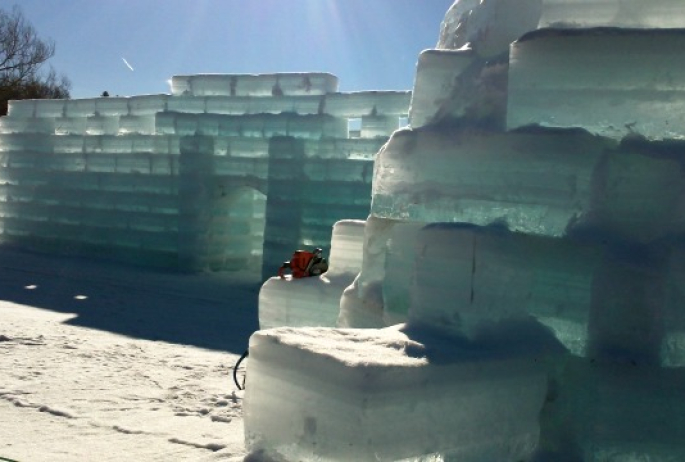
[0,5,71,115]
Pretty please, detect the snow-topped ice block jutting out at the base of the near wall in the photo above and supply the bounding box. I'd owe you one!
[244,328,547,462]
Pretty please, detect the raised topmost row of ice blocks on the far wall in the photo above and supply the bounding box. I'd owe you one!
[171,72,338,96]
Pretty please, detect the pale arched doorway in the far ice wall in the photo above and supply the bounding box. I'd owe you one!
[207,186,266,271]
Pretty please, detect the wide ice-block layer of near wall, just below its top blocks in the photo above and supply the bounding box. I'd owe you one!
[371,129,685,242]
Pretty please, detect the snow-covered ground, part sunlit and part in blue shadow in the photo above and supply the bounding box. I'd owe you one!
[0,248,260,462]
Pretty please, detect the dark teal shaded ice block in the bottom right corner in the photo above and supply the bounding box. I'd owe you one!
[539,359,685,462]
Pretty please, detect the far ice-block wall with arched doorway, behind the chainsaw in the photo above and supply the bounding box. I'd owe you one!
[0,72,410,275]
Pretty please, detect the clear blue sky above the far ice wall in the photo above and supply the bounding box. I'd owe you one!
[6,0,453,98]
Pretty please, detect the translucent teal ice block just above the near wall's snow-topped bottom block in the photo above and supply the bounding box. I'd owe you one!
[408,224,596,346]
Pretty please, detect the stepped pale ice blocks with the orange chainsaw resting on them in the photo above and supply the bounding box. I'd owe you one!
[259,220,364,329]
